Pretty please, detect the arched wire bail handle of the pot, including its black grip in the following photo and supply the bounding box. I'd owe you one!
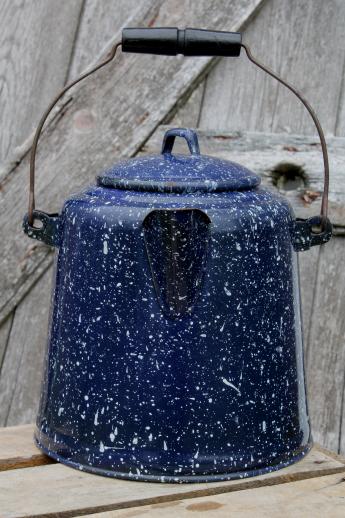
[27,27,330,230]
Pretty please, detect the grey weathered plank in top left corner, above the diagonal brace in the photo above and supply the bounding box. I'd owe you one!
[0,0,82,168]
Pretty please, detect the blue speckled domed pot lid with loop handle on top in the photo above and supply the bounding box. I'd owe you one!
[97,128,261,192]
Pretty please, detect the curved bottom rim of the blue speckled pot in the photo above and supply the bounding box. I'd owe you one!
[34,434,313,484]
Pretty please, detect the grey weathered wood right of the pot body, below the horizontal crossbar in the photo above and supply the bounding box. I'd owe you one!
[307,238,345,451]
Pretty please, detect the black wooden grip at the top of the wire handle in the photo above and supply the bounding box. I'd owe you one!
[122,27,241,57]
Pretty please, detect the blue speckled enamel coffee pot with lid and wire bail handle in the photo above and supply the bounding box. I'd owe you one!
[24,28,332,482]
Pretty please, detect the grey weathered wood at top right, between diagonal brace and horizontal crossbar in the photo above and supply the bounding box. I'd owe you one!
[201,0,345,135]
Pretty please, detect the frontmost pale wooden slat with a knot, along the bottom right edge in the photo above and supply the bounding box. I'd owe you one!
[81,474,345,518]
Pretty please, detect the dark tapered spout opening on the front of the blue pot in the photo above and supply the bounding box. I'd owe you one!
[144,209,210,318]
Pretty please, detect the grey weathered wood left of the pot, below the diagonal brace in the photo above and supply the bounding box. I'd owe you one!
[0,271,51,426]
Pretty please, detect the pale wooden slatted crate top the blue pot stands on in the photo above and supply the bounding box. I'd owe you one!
[0,425,345,518]
